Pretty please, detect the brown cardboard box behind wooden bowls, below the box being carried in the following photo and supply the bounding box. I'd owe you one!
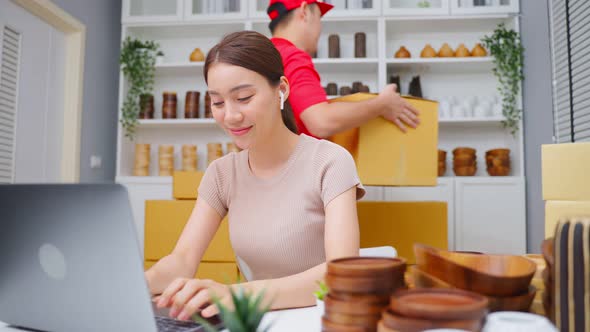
[357,201,448,264]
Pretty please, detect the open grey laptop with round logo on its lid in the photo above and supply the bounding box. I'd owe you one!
[0,184,222,332]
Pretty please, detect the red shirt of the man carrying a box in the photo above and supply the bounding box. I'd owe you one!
[271,38,328,136]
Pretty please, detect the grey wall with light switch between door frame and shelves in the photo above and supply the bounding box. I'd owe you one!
[53,0,123,182]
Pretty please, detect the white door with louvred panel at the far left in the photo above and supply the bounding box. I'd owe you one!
[0,0,65,183]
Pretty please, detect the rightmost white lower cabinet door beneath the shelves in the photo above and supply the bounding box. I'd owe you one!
[455,177,526,254]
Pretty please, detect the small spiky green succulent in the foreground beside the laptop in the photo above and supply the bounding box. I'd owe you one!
[193,286,270,332]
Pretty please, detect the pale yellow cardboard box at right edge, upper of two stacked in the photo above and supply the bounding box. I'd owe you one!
[542,143,590,201]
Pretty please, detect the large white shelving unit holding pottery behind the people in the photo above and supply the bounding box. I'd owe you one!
[117,0,526,253]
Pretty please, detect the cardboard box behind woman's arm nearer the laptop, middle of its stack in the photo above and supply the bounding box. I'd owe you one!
[144,200,235,262]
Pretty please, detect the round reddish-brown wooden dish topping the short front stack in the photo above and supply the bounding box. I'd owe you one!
[389,288,488,320]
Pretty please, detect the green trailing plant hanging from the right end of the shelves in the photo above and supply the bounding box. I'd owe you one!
[482,23,524,135]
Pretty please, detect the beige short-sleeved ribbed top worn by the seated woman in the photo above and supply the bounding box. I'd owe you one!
[199,134,365,280]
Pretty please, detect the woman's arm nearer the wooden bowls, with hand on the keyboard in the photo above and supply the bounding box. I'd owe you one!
[158,186,359,319]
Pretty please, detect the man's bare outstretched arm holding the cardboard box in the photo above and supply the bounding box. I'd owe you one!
[301,84,420,138]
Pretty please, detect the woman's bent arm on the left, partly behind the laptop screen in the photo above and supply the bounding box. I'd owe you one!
[145,198,221,294]
